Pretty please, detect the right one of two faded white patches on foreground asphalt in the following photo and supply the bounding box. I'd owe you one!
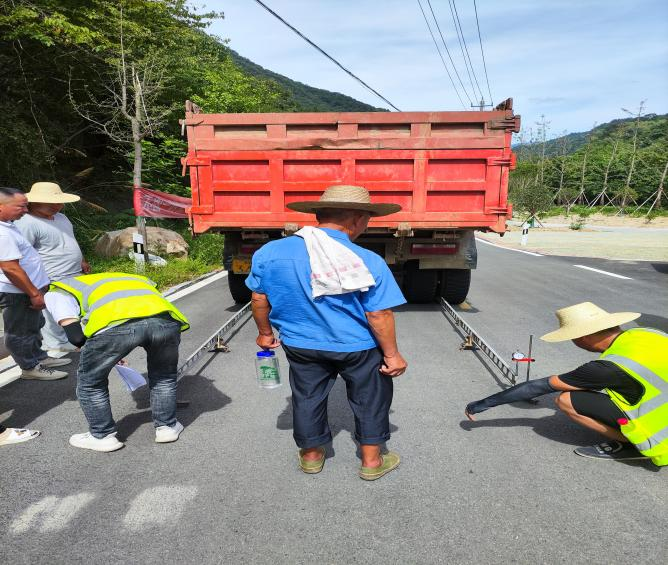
[123,485,197,531]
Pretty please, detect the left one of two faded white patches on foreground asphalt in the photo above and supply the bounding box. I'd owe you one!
[9,492,96,534]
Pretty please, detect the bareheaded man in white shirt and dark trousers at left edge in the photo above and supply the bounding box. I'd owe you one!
[0,187,70,445]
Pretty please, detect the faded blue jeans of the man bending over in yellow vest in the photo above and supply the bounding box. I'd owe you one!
[77,314,181,438]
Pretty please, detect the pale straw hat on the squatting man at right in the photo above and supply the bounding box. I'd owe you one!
[540,302,640,342]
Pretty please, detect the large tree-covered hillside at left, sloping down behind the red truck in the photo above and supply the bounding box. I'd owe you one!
[0,0,374,203]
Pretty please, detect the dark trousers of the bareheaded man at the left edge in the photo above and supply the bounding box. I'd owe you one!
[0,292,47,370]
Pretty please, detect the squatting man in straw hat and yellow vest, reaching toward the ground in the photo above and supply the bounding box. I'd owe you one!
[465,302,668,466]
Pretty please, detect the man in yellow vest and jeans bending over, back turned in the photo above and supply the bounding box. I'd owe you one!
[45,273,190,451]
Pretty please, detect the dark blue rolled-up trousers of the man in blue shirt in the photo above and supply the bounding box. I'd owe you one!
[283,344,393,448]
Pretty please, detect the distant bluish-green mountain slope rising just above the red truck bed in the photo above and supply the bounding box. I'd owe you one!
[229,49,387,112]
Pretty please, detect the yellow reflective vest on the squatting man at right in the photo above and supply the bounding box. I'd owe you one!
[600,328,668,466]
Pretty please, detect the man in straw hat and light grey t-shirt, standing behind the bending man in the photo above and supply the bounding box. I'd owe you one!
[16,182,90,352]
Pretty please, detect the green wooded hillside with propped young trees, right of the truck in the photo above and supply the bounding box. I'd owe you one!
[510,112,668,214]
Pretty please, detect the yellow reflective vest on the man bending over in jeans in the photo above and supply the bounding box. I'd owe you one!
[50,273,190,337]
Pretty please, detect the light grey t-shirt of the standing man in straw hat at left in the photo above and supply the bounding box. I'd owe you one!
[14,212,83,281]
